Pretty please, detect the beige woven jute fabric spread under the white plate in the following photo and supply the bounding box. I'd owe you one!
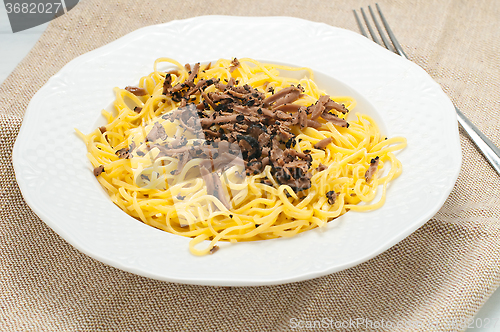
[0,0,500,331]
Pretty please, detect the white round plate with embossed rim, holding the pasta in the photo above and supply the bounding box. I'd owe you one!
[13,16,461,286]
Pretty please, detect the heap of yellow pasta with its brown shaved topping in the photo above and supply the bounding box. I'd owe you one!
[76,58,406,255]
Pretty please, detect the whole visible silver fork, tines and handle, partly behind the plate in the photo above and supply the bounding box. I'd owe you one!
[353,4,500,175]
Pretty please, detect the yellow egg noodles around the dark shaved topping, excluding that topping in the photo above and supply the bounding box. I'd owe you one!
[77,58,406,255]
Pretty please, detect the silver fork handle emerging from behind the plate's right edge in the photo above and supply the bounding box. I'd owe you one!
[455,106,500,174]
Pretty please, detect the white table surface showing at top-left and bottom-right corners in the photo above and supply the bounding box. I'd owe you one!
[0,3,500,332]
